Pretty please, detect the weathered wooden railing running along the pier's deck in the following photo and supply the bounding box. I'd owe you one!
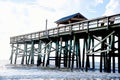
[10,14,120,43]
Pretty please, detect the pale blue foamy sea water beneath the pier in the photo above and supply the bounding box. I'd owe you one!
[0,61,120,80]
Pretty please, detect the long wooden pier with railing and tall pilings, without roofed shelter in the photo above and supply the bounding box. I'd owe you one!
[10,14,120,73]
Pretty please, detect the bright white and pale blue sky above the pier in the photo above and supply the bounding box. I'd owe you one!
[0,0,120,59]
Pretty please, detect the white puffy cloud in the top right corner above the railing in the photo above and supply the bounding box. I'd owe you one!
[104,0,120,15]
